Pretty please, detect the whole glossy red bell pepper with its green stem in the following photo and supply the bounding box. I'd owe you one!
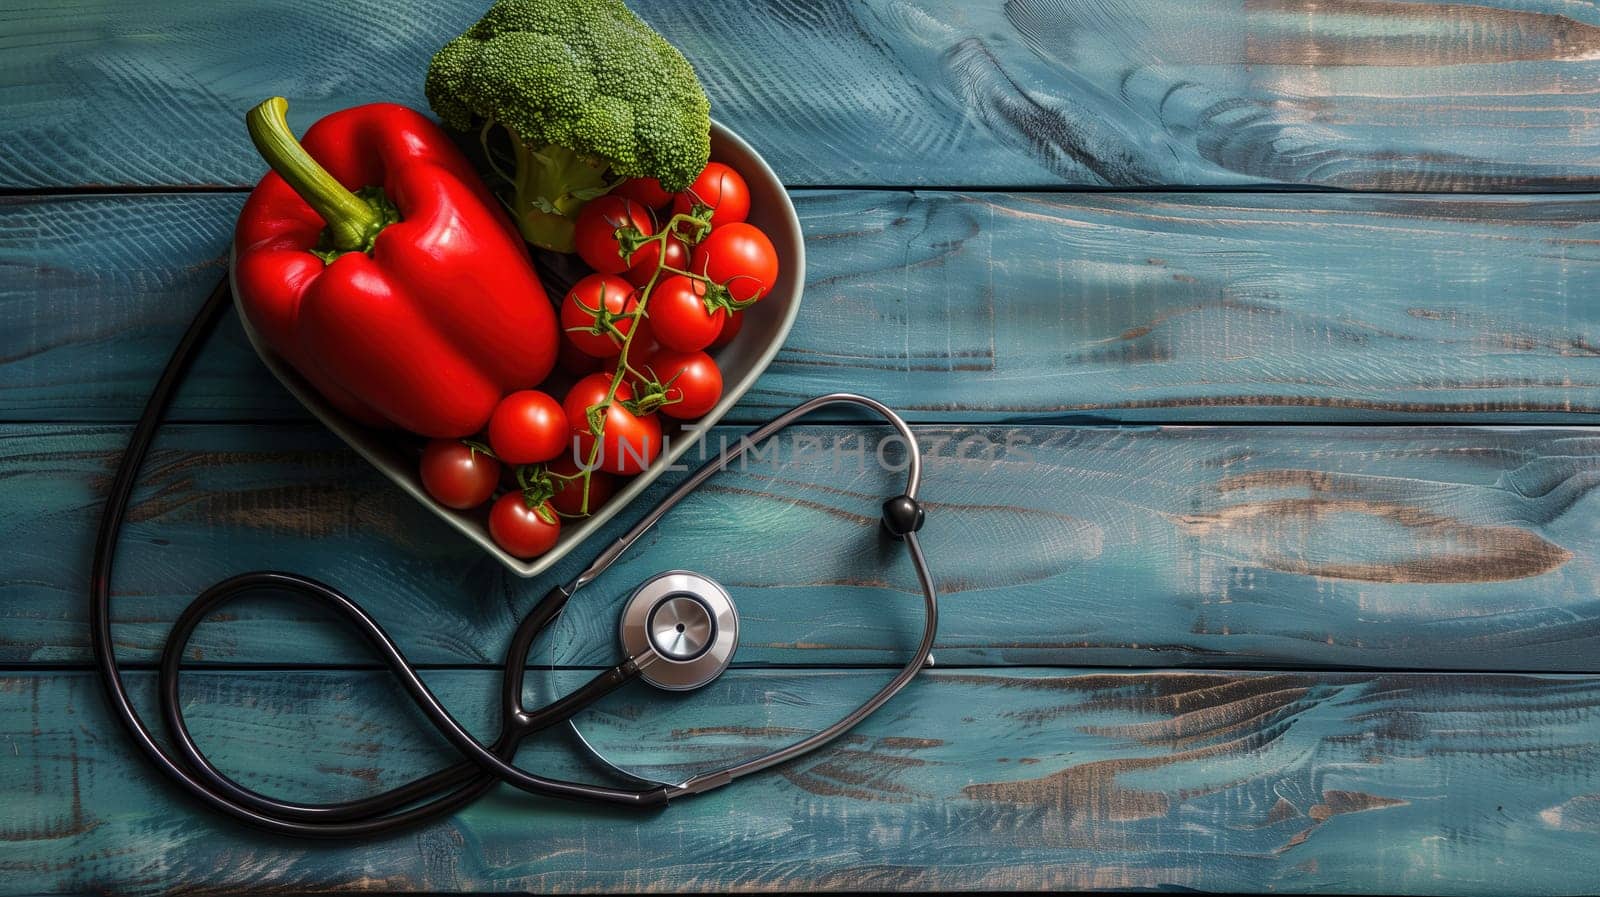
[234,98,560,437]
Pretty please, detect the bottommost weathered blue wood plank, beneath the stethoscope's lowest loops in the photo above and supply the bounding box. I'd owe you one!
[0,670,1600,895]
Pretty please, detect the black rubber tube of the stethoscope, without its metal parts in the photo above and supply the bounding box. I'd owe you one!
[88,278,667,838]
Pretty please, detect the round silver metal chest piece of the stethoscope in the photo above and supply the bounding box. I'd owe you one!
[619,571,739,691]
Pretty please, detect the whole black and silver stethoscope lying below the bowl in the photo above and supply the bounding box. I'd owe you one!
[90,278,939,838]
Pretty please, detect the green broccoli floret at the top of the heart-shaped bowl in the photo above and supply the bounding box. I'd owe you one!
[427,0,710,253]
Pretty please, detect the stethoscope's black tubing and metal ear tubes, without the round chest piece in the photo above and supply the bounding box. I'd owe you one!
[88,278,938,839]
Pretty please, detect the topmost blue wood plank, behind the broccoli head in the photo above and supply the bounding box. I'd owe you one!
[0,0,1600,190]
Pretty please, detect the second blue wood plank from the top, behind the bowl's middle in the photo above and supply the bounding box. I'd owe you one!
[9,190,1600,422]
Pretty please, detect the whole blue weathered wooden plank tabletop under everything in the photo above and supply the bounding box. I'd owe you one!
[0,0,1600,894]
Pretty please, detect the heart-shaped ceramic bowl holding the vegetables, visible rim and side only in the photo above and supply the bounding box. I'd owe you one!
[234,122,805,576]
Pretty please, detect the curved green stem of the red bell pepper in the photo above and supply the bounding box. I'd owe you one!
[245,96,386,253]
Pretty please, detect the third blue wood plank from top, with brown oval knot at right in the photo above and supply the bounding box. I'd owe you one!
[12,425,1600,672]
